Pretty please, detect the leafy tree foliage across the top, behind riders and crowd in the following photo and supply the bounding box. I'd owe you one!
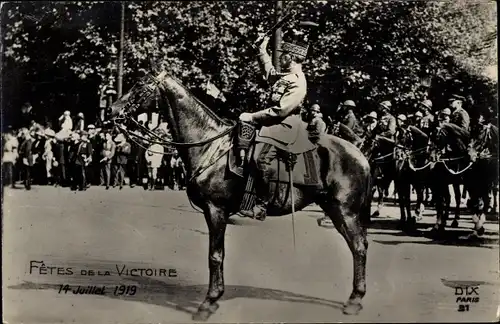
[2,0,497,128]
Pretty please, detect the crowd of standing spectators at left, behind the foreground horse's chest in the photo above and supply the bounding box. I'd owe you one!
[2,106,186,191]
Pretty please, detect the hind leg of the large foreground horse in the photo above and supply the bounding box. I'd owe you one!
[321,203,369,315]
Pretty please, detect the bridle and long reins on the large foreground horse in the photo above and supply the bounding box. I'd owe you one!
[112,71,237,148]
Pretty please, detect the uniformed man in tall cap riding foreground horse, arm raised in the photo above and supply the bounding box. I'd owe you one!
[240,33,307,220]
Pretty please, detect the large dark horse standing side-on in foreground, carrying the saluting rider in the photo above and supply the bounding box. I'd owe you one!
[112,70,370,320]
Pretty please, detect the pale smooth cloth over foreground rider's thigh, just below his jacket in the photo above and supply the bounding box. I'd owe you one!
[255,115,316,154]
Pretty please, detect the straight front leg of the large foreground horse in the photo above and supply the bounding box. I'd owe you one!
[193,205,226,321]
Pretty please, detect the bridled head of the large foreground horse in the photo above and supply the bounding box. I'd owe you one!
[110,62,167,122]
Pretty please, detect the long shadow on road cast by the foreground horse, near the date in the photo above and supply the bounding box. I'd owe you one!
[9,277,343,315]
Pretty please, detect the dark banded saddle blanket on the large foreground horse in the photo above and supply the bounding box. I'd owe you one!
[228,144,321,187]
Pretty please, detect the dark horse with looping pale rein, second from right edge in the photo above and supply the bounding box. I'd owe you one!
[429,123,484,234]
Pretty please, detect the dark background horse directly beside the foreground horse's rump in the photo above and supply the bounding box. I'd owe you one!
[361,135,396,217]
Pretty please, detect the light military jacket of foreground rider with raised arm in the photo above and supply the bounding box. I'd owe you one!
[252,53,307,126]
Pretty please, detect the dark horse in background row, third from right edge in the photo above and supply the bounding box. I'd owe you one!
[394,126,431,230]
